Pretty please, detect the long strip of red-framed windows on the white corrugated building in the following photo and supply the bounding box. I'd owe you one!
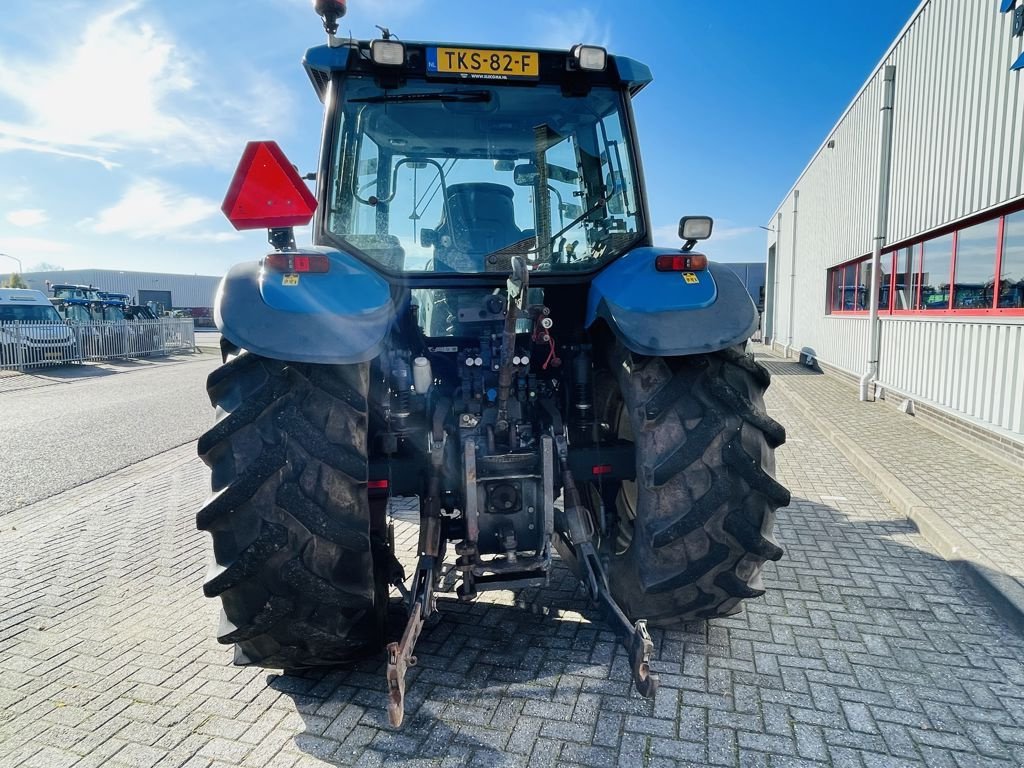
[827,205,1024,314]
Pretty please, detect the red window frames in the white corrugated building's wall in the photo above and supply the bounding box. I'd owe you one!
[825,202,1024,317]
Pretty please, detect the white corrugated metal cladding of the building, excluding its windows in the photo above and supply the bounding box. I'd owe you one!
[768,0,1024,436]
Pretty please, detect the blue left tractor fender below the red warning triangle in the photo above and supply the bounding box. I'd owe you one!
[214,247,395,365]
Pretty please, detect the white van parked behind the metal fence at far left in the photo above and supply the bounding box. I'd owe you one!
[0,288,78,367]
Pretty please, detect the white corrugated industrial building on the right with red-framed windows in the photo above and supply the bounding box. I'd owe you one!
[764,0,1024,459]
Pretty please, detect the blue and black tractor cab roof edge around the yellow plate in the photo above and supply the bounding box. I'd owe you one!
[302,40,653,101]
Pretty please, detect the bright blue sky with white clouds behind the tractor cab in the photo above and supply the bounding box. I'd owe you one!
[0,0,918,274]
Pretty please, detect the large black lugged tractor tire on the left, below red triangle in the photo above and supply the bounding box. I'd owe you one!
[197,351,392,670]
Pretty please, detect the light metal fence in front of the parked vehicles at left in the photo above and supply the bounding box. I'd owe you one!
[0,317,196,371]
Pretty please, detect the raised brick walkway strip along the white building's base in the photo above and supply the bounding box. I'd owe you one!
[757,347,1024,586]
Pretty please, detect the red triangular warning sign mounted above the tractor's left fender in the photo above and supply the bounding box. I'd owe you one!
[220,141,316,229]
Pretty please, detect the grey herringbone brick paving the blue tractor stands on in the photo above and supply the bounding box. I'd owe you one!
[0,376,1024,768]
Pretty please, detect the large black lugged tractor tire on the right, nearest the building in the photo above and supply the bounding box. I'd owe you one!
[595,345,790,627]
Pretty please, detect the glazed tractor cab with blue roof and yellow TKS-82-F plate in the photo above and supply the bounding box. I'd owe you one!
[305,39,650,278]
